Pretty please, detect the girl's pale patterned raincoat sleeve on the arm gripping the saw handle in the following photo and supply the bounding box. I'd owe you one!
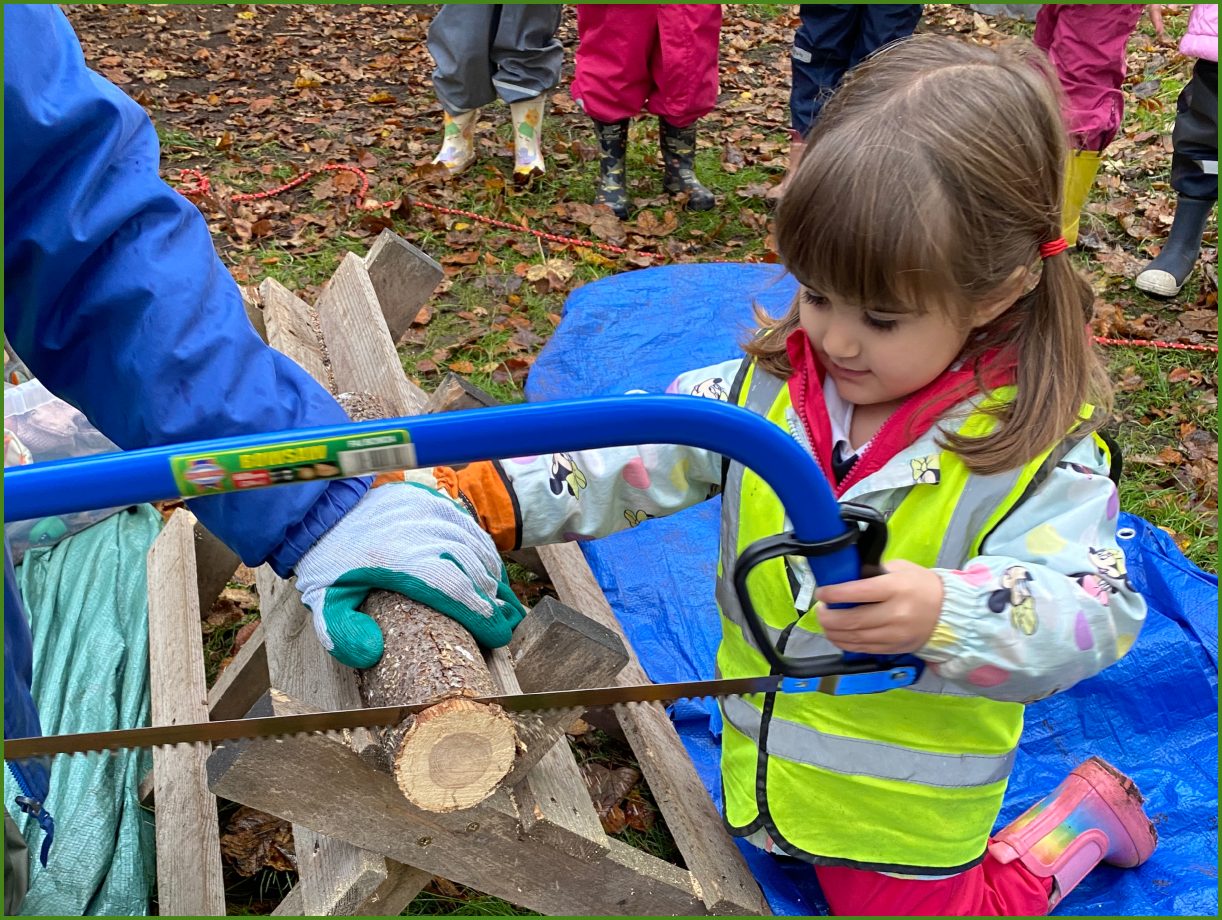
[918,437,1146,703]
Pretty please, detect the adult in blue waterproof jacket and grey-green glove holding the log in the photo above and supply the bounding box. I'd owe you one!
[4,5,522,899]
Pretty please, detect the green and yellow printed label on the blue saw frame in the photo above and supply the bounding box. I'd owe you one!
[170,429,415,498]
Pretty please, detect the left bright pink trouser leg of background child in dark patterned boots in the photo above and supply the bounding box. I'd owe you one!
[571,4,657,123]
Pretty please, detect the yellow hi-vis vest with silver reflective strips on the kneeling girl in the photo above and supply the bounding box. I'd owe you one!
[717,356,1106,875]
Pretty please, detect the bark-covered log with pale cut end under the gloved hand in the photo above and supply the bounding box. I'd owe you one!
[360,591,517,812]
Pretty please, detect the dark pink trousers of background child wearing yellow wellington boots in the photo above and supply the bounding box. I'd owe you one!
[1035,4,1144,150]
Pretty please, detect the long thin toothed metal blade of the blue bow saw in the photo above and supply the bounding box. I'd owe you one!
[4,674,791,760]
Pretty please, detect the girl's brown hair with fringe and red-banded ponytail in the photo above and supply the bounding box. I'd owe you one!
[745,35,1111,473]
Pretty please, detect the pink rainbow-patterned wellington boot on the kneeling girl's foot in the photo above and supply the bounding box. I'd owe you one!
[989,758,1158,910]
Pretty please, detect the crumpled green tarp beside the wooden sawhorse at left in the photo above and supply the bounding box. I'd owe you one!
[5,505,161,916]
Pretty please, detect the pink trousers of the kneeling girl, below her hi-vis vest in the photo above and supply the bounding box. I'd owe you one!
[815,854,1052,916]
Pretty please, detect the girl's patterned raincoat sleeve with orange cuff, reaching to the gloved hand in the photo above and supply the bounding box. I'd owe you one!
[420,359,741,550]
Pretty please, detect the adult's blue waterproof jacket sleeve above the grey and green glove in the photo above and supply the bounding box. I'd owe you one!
[4,5,368,574]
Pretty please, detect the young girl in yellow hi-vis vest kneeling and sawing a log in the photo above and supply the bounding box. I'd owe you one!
[371,35,1156,915]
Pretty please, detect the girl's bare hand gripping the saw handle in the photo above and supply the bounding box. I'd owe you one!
[815,560,942,655]
